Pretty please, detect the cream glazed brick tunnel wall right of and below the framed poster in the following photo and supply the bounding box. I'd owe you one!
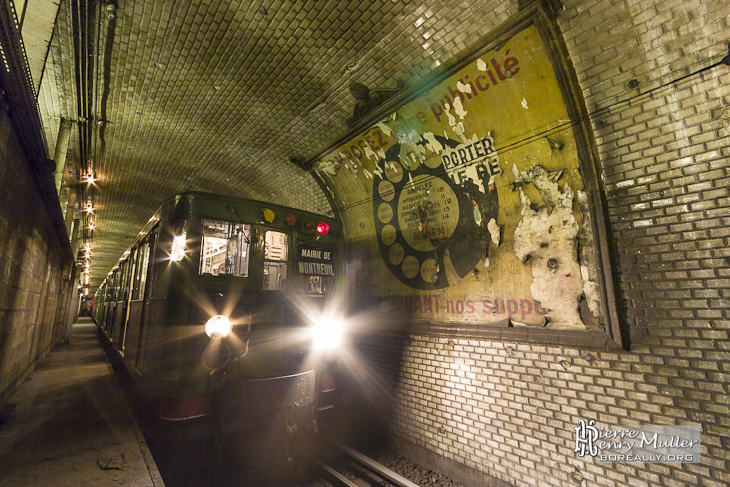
[336,0,730,487]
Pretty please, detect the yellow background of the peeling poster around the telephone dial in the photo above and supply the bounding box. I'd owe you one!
[315,26,583,326]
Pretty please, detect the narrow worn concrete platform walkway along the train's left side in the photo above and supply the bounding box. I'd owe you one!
[0,318,164,487]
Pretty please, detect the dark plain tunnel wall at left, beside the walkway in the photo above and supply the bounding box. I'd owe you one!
[0,105,73,405]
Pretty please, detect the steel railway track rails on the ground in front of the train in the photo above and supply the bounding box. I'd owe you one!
[316,444,420,487]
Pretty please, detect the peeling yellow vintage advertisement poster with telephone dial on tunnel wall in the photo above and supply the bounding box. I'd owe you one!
[315,26,601,330]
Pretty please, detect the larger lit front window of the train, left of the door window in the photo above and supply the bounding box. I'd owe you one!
[200,219,251,277]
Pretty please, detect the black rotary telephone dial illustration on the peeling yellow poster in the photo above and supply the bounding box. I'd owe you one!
[373,135,499,290]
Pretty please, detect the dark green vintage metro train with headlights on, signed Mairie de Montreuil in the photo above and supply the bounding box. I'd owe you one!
[93,192,343,462]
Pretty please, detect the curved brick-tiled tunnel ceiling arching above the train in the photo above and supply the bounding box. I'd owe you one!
[34,0,517,292]
